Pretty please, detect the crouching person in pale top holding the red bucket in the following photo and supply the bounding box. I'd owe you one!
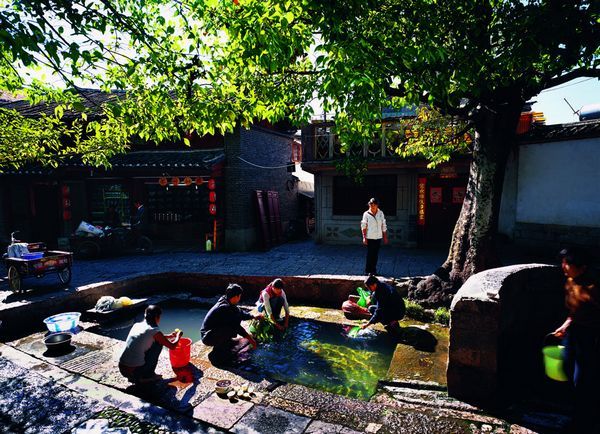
[119,305,182,383]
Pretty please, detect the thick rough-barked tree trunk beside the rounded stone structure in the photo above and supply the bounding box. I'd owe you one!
[409,101,523,306]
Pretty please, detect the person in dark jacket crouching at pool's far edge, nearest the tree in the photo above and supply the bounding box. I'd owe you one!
[361,275,406,332]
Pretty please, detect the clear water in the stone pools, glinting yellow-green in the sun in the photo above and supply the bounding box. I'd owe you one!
[96,302,395,399]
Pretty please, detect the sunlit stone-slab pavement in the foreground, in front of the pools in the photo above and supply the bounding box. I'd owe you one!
[0,302,531,434]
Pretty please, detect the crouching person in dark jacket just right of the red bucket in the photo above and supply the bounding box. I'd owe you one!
[200,283,263,363]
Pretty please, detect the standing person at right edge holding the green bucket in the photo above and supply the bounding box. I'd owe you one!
[553,248,600,433]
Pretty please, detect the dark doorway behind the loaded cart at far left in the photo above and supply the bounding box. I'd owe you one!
[27,184,60,248]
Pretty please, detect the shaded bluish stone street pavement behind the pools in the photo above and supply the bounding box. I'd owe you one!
[0,240,447,291]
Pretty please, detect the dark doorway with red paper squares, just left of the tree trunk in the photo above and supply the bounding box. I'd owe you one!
[424,176,467,244]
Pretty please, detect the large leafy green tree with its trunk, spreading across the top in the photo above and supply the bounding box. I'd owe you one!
[0,0,600,287]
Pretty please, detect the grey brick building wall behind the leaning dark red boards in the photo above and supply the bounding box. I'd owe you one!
[225,124,298,251]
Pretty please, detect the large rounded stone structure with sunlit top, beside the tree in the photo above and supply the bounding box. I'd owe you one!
[447,264,566,406]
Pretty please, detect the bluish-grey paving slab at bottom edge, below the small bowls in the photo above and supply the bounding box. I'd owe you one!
[231,405,311,434]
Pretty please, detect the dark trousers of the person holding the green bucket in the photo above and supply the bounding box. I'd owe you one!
[563,324,600,433]
